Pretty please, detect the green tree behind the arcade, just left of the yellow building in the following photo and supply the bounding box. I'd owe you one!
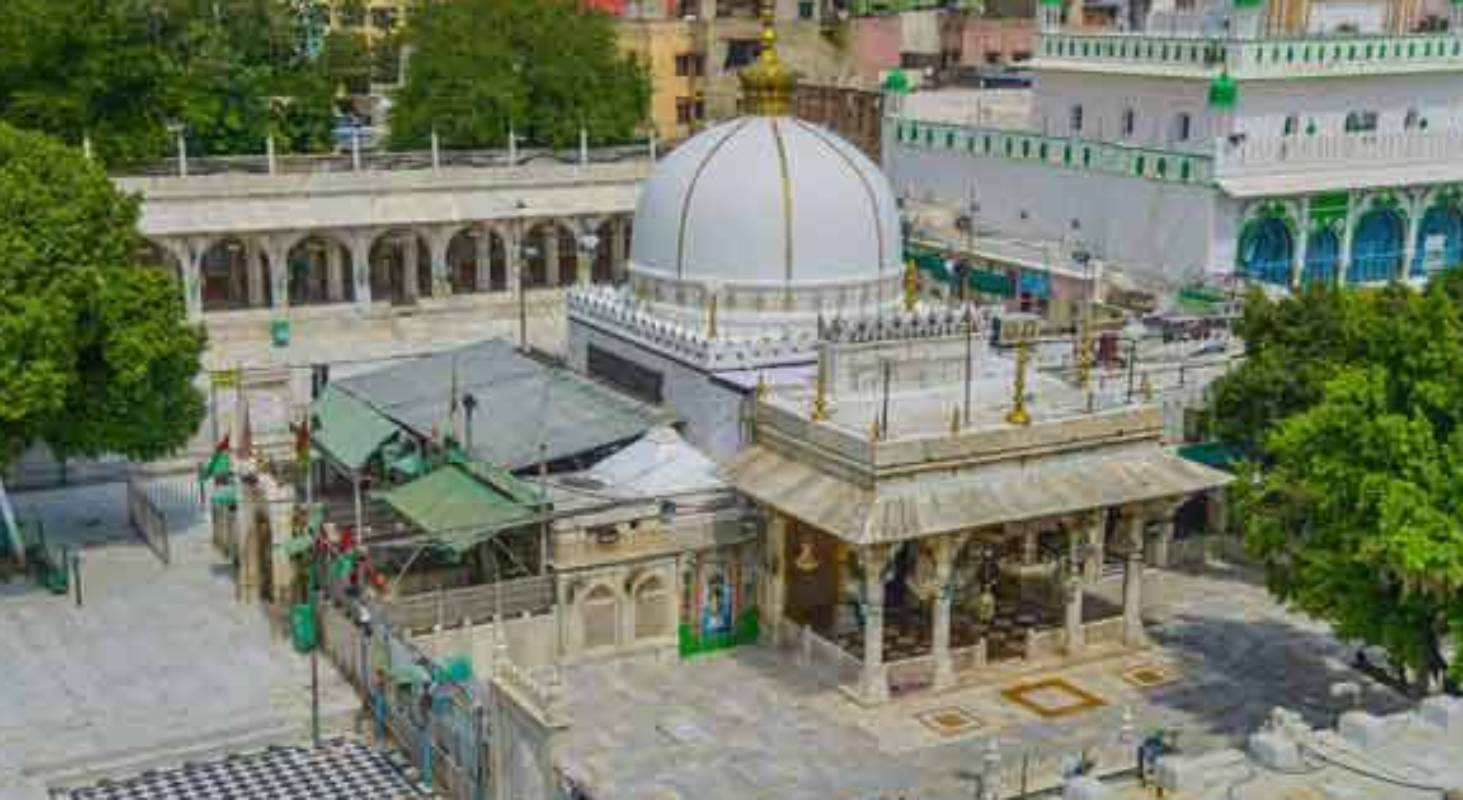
[391,0,650,148]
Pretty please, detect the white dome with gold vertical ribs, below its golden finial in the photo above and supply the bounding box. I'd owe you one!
[631,116,900,288]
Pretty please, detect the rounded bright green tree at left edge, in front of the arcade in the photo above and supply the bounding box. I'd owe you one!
[0,123,205,468]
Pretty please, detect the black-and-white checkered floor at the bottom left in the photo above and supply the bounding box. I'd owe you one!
[66,740,424,800]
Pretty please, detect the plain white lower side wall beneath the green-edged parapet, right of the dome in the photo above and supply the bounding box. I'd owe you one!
[884,145,1233,282]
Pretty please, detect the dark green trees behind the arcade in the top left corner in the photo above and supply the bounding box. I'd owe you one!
[0,0,332,164]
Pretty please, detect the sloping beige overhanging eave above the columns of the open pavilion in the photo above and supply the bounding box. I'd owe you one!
[723,446,1232,544]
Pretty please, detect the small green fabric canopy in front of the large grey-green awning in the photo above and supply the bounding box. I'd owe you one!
[376,464,537,553]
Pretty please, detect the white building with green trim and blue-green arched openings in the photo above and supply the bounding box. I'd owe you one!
[884,0,1463,287]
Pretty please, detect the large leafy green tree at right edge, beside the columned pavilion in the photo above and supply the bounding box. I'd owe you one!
[1216,278,1463,687]
